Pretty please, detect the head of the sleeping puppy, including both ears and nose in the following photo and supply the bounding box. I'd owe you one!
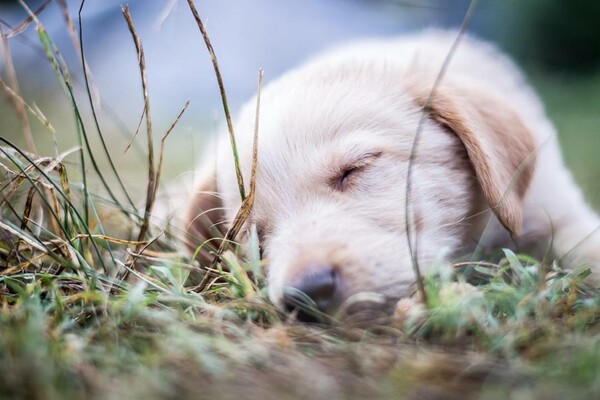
[184,59,535,320]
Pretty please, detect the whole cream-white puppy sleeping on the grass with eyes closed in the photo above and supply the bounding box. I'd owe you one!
[185,31,600,320]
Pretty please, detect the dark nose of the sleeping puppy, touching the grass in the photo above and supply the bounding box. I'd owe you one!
[283,267,337,322]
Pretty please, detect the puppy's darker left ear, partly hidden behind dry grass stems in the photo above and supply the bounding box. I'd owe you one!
[183,166,225,259]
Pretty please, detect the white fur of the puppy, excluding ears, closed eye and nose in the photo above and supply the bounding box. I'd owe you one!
[188,31,600,310]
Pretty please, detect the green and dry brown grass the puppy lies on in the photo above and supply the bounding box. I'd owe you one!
[0,1,600,399]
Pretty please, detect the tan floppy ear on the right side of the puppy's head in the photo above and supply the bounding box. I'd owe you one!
[407,80,536,235]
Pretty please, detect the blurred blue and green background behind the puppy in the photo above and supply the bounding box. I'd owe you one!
[0,0,600,209]
